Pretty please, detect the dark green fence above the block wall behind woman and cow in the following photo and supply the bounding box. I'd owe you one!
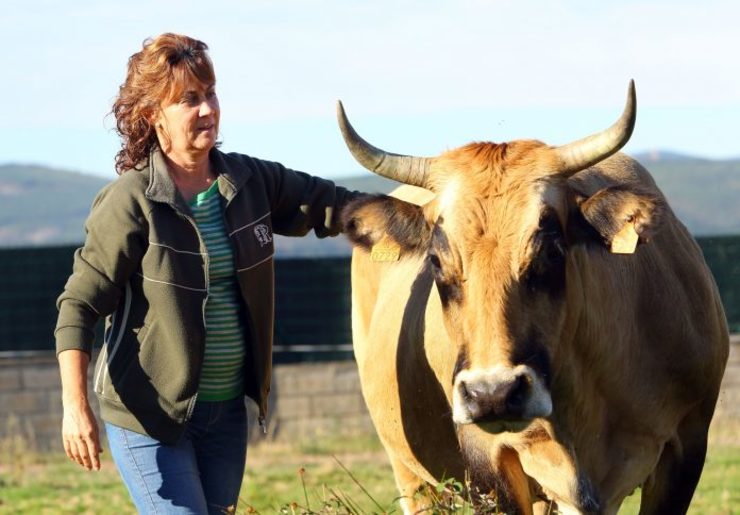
[0,236,740,363]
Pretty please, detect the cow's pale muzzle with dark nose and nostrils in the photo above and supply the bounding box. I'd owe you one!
[452,365,552,431]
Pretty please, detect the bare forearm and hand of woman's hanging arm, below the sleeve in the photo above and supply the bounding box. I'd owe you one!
[59,350,103,470]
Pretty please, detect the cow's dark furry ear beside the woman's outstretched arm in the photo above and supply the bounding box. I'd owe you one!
[341,195,431,251]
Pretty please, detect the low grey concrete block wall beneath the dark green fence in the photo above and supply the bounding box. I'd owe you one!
[0,336,740,451]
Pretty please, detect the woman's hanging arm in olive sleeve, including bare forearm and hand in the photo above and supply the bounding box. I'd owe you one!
[55,180,146,470]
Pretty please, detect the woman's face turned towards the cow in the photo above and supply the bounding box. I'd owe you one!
[155,81,221,156]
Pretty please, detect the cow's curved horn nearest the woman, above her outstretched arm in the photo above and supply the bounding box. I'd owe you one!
[337,100,431,188]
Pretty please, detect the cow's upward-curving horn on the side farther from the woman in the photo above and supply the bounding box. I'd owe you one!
[556,80,637,174]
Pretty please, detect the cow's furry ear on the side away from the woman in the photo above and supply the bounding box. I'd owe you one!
[576,185,665,249]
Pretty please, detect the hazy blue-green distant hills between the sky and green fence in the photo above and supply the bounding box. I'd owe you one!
[0,155,740,257]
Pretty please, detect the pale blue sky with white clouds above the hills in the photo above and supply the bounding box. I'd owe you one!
[0,0,740,178]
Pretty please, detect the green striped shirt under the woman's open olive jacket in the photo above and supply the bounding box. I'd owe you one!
[189,180,245,401]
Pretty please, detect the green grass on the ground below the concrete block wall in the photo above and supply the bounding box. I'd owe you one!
[0,430,740,515]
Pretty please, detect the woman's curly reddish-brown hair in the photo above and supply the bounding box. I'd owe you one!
[111,33,216,175]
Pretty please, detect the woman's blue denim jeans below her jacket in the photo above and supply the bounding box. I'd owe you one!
[105,397,247,514]
